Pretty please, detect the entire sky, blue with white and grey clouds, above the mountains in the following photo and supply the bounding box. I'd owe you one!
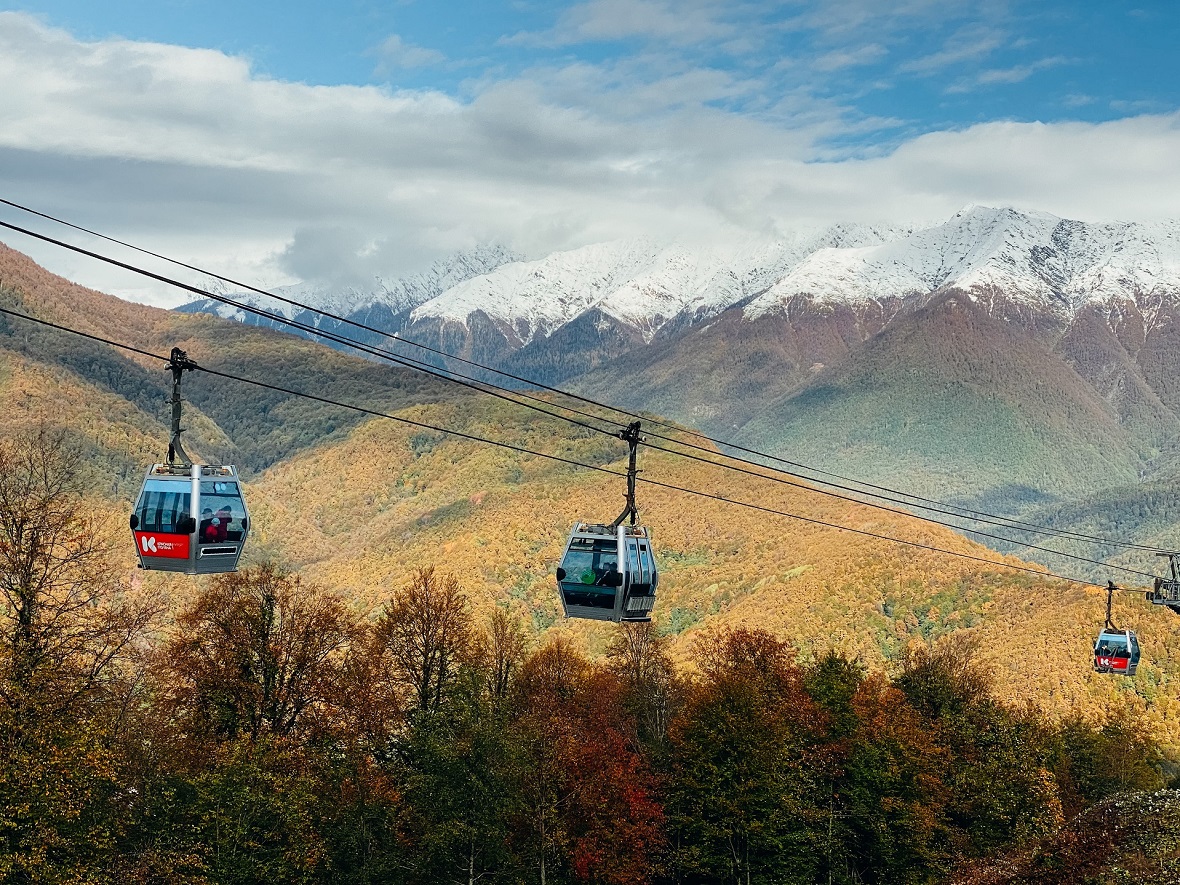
[0,0,1180,295]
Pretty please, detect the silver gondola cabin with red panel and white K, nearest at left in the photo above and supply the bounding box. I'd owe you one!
[131,464,249,575]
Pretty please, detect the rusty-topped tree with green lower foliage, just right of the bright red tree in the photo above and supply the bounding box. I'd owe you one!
[666,629,831,884]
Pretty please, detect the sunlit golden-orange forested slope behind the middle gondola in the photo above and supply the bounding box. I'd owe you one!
[250,402,1180,746]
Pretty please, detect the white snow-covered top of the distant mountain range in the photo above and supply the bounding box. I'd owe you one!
[181,207,1180,349]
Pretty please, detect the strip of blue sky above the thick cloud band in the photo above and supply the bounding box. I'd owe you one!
[13,0,1180,139]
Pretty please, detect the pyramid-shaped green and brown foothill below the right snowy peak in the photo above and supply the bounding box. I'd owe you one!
[736,294,1143,512]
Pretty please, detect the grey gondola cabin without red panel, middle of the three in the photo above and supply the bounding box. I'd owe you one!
[557,523,660,623]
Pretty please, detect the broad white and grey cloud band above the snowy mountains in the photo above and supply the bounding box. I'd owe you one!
[0,13,1180,303]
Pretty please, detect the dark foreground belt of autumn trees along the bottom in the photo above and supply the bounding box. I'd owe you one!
[0,432,1180,885]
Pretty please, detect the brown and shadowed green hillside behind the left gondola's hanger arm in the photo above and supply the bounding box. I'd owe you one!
[0,239,469,473]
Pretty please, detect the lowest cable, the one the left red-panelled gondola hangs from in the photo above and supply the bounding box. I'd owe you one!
[0,302,1102,586]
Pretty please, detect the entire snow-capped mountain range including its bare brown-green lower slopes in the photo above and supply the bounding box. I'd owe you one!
[168,207,1180,564]
